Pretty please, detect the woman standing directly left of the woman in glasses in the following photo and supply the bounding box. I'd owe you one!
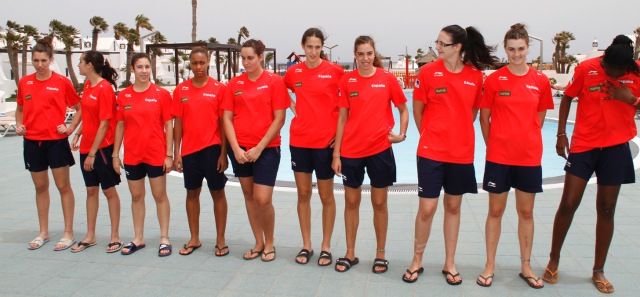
[331,36,409,273]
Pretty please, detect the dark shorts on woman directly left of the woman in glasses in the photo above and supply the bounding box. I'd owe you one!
[340,148,396,188]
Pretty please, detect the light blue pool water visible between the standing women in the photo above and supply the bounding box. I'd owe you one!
[227,90,573,184]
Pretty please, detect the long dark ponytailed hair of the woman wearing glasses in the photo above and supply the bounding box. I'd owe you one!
[441,25,500,70]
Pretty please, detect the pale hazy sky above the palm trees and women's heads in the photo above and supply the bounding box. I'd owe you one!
[0,0,640,62]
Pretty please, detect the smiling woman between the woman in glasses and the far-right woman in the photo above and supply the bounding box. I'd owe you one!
[476,24,553,289]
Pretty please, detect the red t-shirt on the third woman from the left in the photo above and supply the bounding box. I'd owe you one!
[117,84,171,166]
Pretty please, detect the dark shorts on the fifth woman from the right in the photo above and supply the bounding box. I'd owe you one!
[289,146,335,179]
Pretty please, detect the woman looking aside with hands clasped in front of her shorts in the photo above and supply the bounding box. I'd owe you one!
[222,39,290,262]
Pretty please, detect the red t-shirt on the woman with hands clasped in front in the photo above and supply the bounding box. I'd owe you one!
[222,71,291,148]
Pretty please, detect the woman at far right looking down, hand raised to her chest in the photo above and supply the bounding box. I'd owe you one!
[543,35,640,293]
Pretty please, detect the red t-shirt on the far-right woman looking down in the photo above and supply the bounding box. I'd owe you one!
[564,57,640,153]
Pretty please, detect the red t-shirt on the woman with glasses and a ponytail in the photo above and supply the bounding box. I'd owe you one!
[413,60,482,164]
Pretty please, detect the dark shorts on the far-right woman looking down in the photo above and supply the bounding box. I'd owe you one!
[564,142,636,186]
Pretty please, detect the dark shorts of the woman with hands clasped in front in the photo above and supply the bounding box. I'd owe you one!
[228,147,280,187]
